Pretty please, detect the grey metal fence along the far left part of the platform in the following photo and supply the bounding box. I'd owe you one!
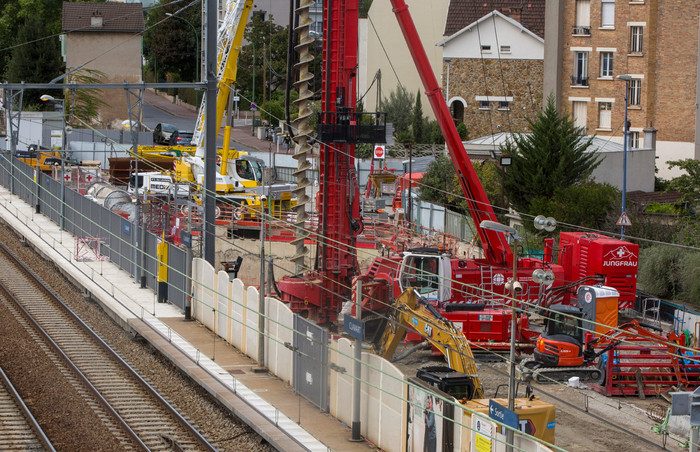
[0,152,190,309]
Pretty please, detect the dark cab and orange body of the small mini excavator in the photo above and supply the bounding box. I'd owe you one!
[534,305,585,367]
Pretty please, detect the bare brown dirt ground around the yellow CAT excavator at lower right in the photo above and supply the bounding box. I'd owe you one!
[394,345,687,452]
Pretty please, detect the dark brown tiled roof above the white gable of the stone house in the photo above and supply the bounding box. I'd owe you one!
[445,0,544,38]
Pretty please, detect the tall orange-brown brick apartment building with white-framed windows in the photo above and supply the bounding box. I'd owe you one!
[544,0,700,179]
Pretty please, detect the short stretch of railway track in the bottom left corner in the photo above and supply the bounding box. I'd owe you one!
[0,369,54,451]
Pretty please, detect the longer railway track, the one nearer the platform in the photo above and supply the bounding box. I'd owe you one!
[0,244,216,451]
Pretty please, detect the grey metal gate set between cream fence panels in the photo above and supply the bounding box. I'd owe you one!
[294,315,328,411]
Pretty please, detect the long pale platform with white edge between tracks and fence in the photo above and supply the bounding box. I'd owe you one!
[0,186,375,451]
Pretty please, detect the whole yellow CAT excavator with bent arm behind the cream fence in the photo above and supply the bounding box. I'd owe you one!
[372,288,555,443]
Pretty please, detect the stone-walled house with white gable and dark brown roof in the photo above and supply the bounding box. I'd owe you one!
[438,0,544,138]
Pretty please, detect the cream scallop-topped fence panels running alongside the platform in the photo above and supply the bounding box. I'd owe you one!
[192,258,550,452]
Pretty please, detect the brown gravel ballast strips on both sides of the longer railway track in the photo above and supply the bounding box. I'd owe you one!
[0,224,275,452]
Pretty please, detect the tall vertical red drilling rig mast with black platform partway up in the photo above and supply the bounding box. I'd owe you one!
[277,0,386,323]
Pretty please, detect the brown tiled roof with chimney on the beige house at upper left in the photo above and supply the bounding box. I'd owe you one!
[62,2,145,33]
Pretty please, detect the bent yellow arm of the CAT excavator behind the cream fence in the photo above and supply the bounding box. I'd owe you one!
[373,288,484,398]
